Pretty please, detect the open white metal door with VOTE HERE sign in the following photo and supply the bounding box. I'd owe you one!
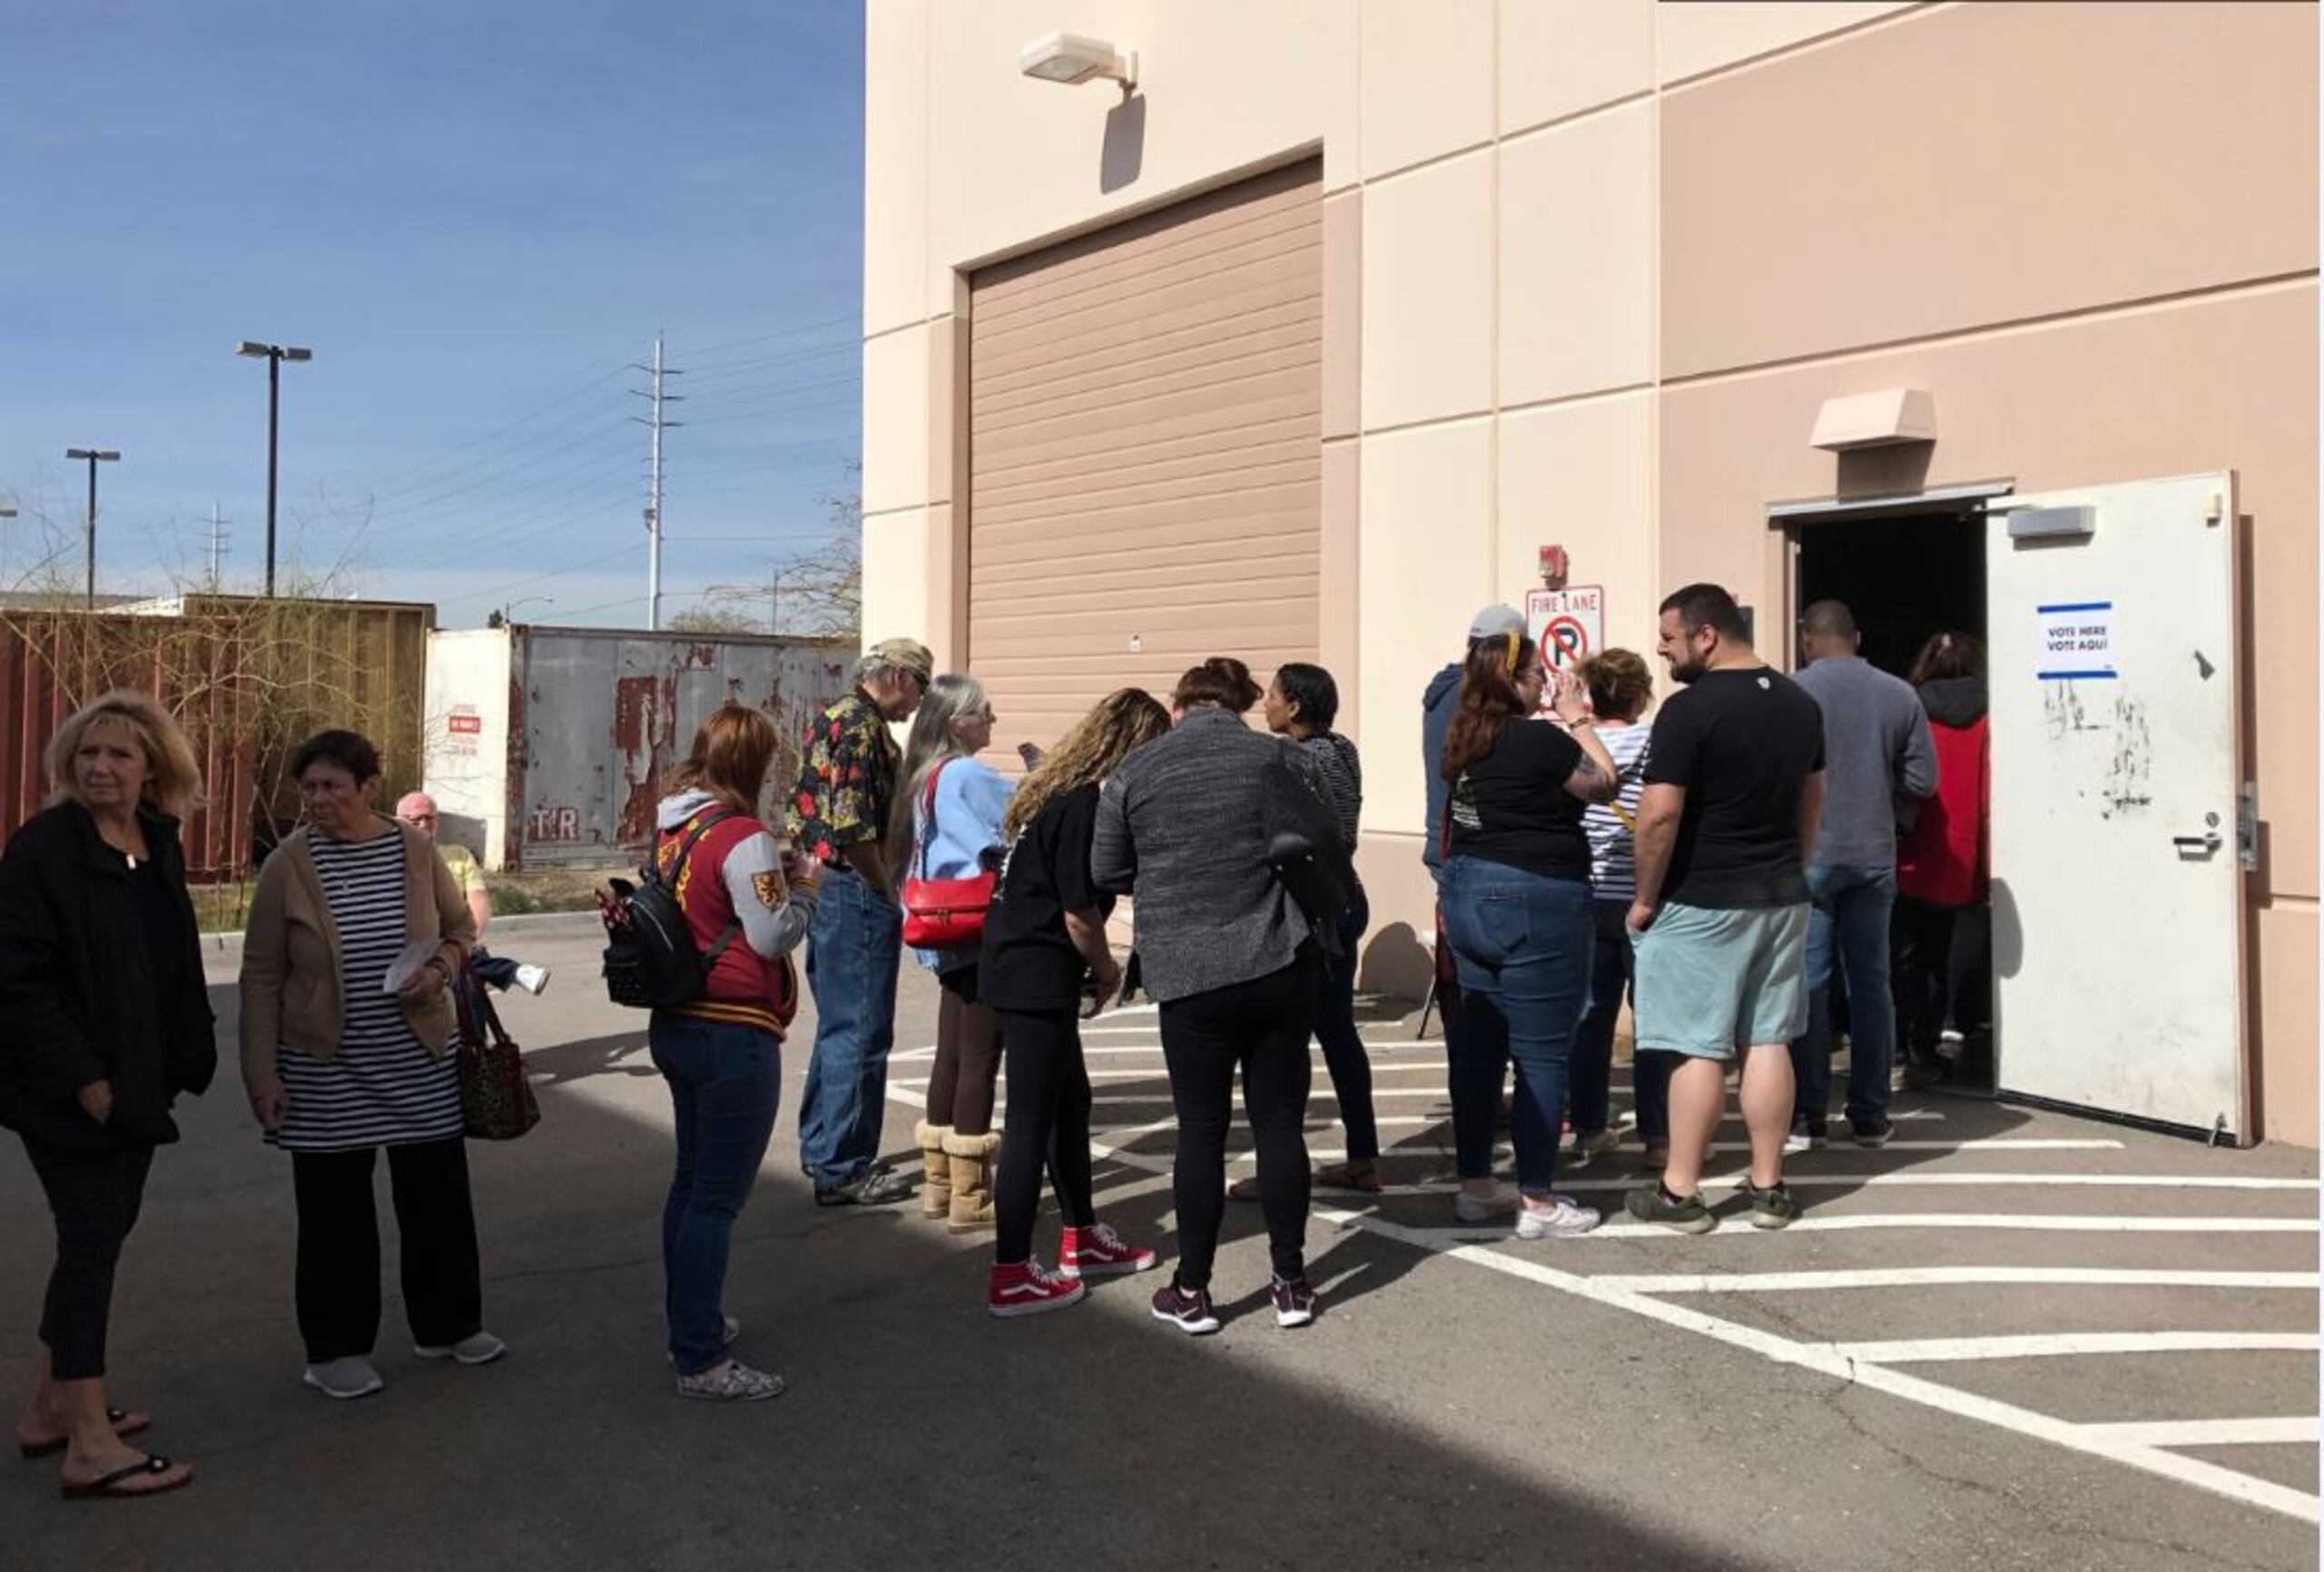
[1987,474,2248,1138]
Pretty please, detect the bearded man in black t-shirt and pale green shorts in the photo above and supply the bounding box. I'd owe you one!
[1627,585,1825,1233]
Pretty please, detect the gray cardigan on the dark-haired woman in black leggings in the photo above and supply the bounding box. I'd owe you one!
[1090,708,1313,1003]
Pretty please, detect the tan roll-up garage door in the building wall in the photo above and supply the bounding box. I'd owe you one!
[970,161,1323,764]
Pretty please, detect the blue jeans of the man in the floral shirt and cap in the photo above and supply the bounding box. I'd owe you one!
[800,869,904,1189]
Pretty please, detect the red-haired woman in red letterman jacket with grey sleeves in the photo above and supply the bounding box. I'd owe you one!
[651,703,816,1402]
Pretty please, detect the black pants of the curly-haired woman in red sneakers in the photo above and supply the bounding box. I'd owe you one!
[992,1007,1097,1265]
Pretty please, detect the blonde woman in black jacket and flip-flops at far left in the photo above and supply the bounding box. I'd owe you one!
[0,692,219,1498]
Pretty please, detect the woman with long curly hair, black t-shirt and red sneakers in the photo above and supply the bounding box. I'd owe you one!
[980,687,1169,1317]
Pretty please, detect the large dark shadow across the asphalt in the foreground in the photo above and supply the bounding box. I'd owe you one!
[0,989,1785,1572]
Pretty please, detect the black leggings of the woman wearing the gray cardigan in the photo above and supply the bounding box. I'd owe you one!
[1162,948,1323,1289]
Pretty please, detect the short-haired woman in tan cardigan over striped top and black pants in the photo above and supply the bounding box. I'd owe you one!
[241,732,486,1398]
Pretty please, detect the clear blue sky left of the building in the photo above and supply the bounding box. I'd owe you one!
[0,0,862,627]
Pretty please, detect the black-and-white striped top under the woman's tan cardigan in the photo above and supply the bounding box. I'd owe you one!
[270,833,460,1152]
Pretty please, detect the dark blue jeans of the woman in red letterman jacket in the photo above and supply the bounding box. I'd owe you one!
[646,1010,783,1375]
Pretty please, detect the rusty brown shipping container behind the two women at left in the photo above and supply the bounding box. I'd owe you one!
[0,596,435,880]
